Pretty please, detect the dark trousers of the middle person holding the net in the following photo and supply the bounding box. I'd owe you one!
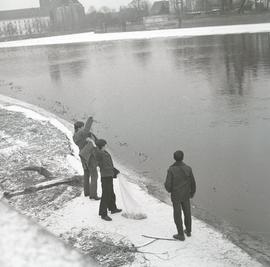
[99,177,116,216]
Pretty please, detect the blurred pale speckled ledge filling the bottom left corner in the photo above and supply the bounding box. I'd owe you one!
[0,203,97,267]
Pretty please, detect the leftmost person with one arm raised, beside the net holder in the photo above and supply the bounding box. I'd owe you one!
[73,117,100,200]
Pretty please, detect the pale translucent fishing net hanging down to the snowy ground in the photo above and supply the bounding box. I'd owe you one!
[117,175,147,220]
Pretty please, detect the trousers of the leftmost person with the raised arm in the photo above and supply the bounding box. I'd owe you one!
[81,158,98,197]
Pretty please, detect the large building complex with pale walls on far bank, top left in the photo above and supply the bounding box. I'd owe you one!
[0,0,85,39]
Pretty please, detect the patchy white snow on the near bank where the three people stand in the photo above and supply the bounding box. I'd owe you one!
[0,95,262,267]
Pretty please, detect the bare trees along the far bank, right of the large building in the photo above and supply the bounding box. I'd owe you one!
[85,0,270,32]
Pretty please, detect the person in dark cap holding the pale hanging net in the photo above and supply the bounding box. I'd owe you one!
[96,139,122,221]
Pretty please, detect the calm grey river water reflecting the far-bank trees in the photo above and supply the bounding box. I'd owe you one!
[0,33,270,253]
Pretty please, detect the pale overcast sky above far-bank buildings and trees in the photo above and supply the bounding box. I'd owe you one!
[0,0,131,11]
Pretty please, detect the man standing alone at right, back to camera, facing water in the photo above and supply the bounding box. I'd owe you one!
[165,150,196,241]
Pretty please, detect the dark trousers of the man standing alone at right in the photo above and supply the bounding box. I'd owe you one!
[173,199,191,235]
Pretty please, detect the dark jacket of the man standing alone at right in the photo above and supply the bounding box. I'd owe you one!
[164,161,196,201]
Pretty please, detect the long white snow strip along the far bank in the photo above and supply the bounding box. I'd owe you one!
[0,23,270,48]
